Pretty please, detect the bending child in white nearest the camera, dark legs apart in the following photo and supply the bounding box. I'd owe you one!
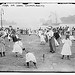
[26,52,37,68]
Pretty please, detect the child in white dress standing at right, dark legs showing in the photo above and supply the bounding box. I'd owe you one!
[61,35,72,59]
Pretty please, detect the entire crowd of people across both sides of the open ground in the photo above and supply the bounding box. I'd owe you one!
[0,26,75,68]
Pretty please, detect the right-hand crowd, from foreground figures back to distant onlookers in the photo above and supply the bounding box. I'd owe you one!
[38,26,75,59]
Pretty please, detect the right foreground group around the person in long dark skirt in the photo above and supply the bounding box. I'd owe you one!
[39,28,75,59]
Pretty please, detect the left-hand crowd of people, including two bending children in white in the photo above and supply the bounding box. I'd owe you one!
[0,26,37,68]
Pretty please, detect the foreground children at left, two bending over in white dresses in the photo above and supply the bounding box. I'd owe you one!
[0,31,37,68]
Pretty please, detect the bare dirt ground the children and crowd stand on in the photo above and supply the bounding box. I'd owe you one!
[0,35,75,72]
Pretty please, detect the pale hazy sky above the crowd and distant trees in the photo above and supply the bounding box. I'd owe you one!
[0,1,75,28]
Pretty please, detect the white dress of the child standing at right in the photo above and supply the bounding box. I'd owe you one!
[61,39,72,55]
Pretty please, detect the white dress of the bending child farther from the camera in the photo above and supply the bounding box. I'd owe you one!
[12,41,23,54]
